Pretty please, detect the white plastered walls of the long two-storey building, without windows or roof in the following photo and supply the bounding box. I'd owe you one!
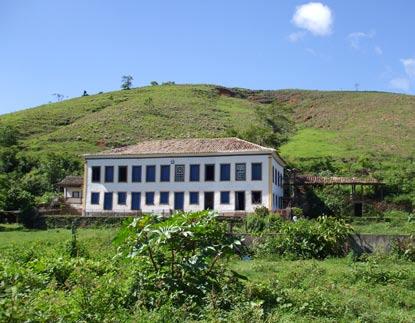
[85,154,282,213]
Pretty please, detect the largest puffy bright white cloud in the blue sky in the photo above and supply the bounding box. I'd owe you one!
[292,2,333,36]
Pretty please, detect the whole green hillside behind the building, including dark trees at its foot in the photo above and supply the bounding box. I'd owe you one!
[0,84,415,215]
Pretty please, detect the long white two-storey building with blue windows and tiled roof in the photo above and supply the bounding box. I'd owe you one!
[84,138,285,215]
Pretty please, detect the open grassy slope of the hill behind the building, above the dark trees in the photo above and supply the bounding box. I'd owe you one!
[0,85,415,160]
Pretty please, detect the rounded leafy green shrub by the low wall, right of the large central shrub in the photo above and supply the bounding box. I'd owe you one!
[259,216,351,259]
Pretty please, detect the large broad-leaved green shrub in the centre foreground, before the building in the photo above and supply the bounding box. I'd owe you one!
[117,211,247,311]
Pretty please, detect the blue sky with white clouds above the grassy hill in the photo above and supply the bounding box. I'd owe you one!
[0,0,415,114]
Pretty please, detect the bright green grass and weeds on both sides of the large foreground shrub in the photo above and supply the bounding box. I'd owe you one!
[0,227,415,322]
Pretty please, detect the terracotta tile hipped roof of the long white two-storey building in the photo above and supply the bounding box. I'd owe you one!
[86,138,275,156]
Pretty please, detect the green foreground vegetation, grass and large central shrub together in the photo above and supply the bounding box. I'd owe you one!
[0,212,415,322]
